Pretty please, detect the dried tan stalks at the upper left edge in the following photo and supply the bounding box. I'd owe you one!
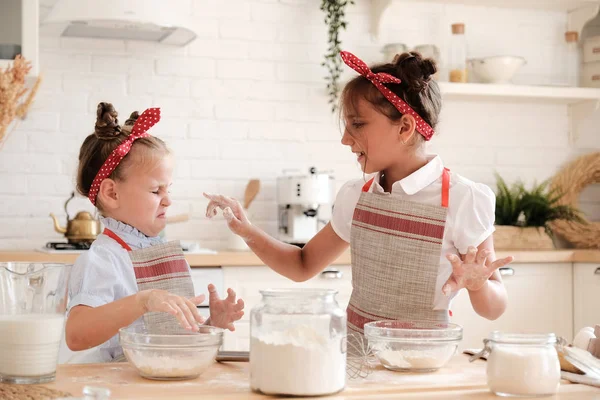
[0,55,41,146]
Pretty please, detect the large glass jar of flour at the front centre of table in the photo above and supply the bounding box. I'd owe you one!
[250,289,346,396]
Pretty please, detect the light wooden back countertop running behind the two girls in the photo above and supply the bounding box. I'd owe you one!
[0,250,600,267]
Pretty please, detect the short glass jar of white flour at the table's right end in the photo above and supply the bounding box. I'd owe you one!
[486,331,560,397]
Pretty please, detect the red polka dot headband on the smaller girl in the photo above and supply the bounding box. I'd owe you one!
[88,108,160,205]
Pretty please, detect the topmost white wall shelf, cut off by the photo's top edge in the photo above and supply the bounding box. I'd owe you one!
[370,0,600,37]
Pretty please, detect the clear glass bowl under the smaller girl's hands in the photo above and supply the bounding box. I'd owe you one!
[119,324,223,380]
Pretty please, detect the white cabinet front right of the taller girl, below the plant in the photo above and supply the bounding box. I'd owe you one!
[451,263,576,349]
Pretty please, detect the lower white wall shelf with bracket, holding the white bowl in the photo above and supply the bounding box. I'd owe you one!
[439,82,600,143]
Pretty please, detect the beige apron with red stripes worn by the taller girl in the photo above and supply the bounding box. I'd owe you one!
[347,169,450,346]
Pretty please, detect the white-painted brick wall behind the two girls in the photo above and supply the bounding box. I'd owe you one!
[0,0,600,249]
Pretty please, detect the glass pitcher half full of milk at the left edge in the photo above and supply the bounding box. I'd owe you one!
[0,262,72,384]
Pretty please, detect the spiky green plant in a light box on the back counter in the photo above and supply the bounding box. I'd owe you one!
[494,174,583,250]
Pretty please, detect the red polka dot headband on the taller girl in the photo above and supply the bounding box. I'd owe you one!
[340,51,434,140]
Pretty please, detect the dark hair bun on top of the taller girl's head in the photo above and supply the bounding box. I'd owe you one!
[393,51,437,92]
